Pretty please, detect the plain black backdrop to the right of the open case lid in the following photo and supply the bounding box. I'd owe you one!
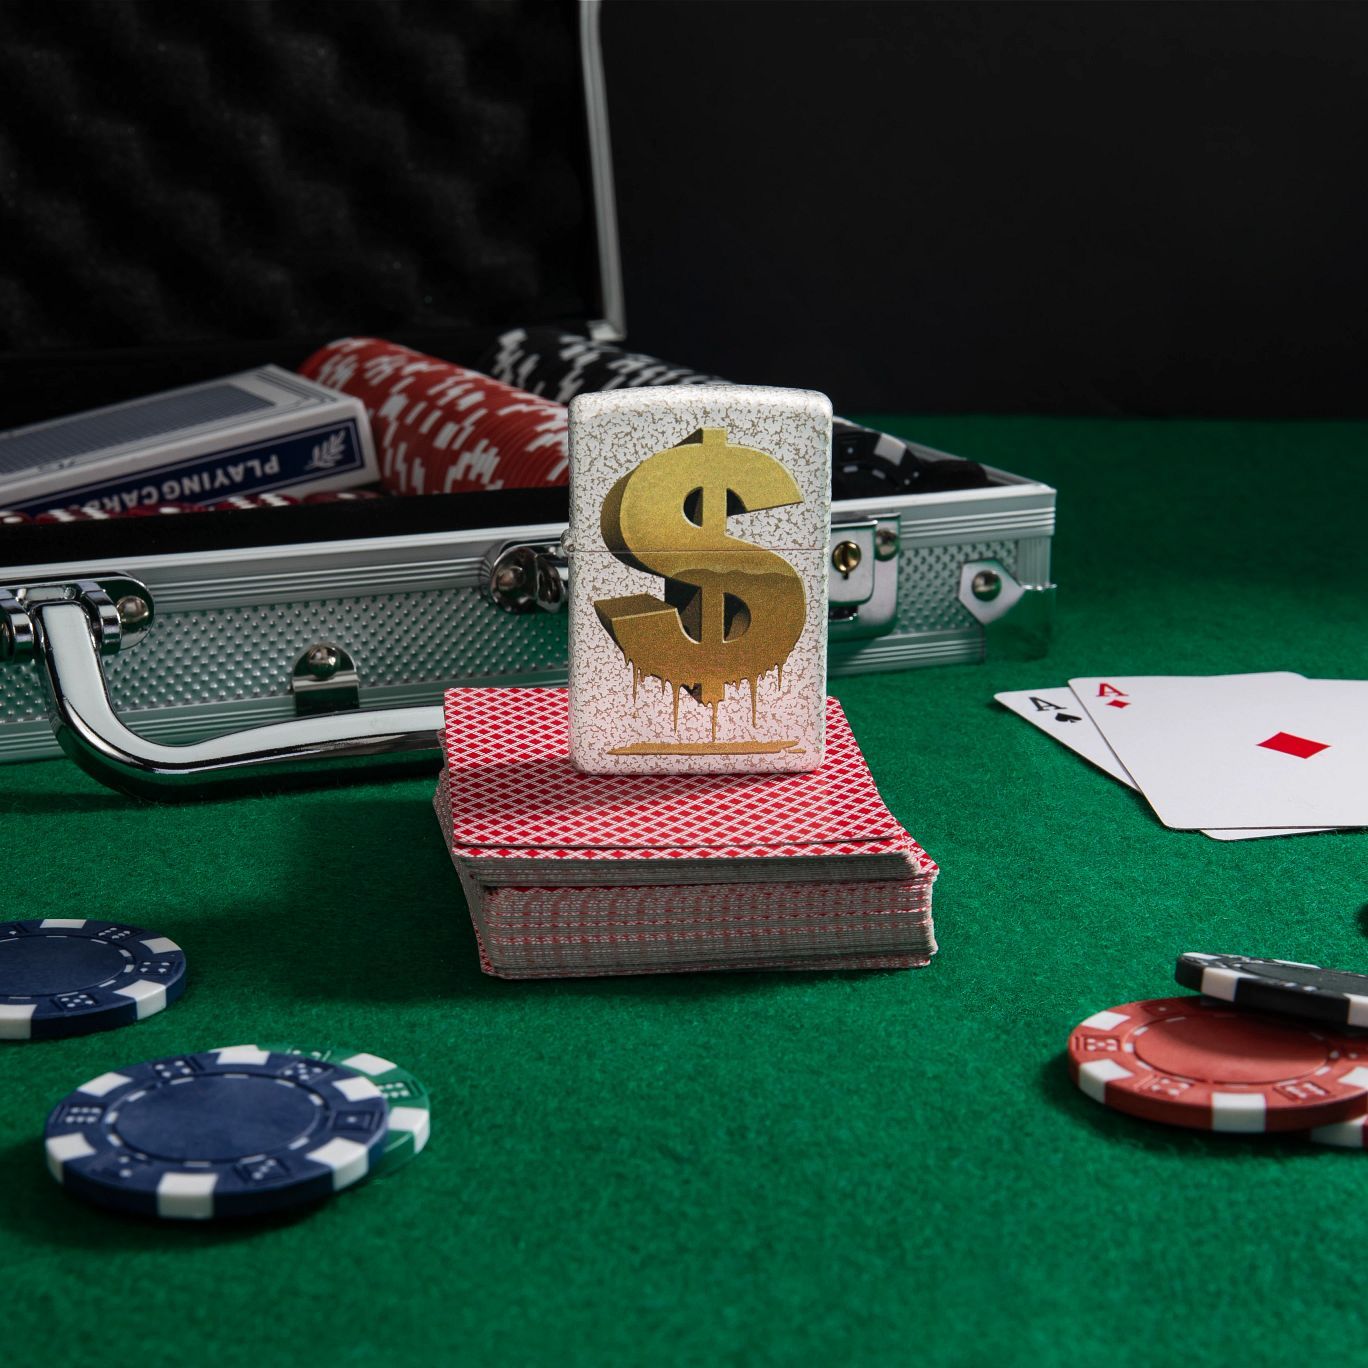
[603,0,1368,416]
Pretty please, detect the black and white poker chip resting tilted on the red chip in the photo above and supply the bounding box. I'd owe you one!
[1174,953,1368,1027]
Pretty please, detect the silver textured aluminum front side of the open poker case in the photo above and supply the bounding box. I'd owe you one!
[0,471,1055,761]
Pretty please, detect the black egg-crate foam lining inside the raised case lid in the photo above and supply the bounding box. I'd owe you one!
[0,0,599,427]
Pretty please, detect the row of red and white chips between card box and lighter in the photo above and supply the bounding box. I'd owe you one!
[300,338,569,494]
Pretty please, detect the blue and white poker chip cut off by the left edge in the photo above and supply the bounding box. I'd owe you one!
[0,917,185,1040]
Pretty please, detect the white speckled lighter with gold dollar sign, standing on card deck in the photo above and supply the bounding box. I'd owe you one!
[564,384,832,774]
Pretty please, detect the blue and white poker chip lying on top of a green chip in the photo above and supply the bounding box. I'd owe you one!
[44,1045,389,1220]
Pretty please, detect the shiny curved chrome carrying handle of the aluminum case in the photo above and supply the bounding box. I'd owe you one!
[29,591,442,802]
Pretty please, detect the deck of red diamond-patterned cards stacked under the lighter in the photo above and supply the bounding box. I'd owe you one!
[434,688,937,978]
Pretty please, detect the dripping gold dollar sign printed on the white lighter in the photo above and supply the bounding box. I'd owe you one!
[594,428,807,755]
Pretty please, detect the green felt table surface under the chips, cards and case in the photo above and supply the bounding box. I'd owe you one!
[0,419,1368,1368]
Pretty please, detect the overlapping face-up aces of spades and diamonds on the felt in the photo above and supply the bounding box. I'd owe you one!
[995,673,1368,841]
